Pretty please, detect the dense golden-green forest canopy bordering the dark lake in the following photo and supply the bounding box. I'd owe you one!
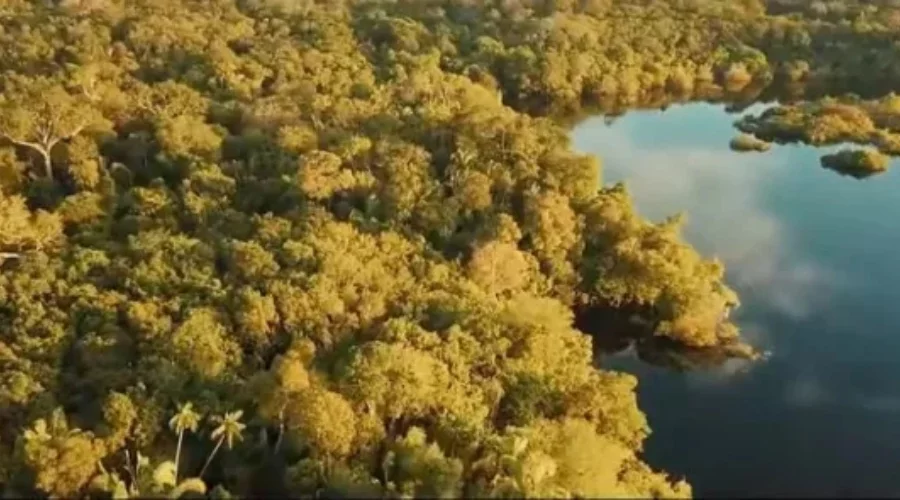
[0,0,900,498]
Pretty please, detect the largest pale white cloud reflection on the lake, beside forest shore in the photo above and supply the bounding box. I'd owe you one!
[575,114,835,326]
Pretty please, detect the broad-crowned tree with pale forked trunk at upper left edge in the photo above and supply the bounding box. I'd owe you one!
[0,76,105,179]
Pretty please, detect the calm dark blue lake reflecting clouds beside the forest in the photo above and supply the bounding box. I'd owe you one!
[573,104,900,497]
